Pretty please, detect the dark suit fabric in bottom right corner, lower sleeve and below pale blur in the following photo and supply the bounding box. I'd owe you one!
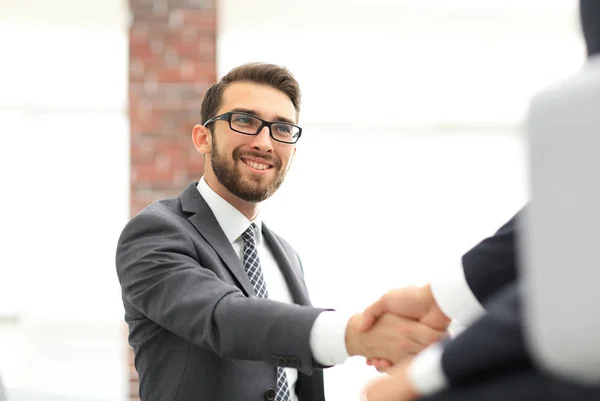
[432,283,600,401]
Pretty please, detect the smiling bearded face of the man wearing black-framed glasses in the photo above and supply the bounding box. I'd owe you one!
[207,82,296,203]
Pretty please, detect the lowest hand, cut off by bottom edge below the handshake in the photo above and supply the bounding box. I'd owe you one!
[364,363,419,401]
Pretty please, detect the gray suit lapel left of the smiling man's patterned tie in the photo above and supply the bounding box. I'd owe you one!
[179,183,254,296]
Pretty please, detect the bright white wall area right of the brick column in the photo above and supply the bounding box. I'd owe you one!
[217,0,584,401]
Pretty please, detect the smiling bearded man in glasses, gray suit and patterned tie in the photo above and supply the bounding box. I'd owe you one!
[116,64,443,401]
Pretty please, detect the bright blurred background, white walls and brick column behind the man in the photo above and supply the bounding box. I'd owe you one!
[0,0,584,401]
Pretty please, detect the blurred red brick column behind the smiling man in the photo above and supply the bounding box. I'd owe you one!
[128,0,216,400]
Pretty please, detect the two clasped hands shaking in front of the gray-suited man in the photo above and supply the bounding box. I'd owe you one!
[346,286,450,372]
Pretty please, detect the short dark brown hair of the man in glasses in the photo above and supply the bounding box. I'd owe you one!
[200,63,300,124]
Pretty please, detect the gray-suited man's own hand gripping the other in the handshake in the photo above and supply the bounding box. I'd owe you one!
[346,313,445,364]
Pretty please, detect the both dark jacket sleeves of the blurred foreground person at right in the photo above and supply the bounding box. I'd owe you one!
[442,207,531,386]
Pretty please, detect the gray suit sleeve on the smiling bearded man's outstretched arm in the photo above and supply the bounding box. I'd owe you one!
[116,212,322,374]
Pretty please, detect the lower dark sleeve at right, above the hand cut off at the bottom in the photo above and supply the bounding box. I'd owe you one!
[442,283,530,387]
